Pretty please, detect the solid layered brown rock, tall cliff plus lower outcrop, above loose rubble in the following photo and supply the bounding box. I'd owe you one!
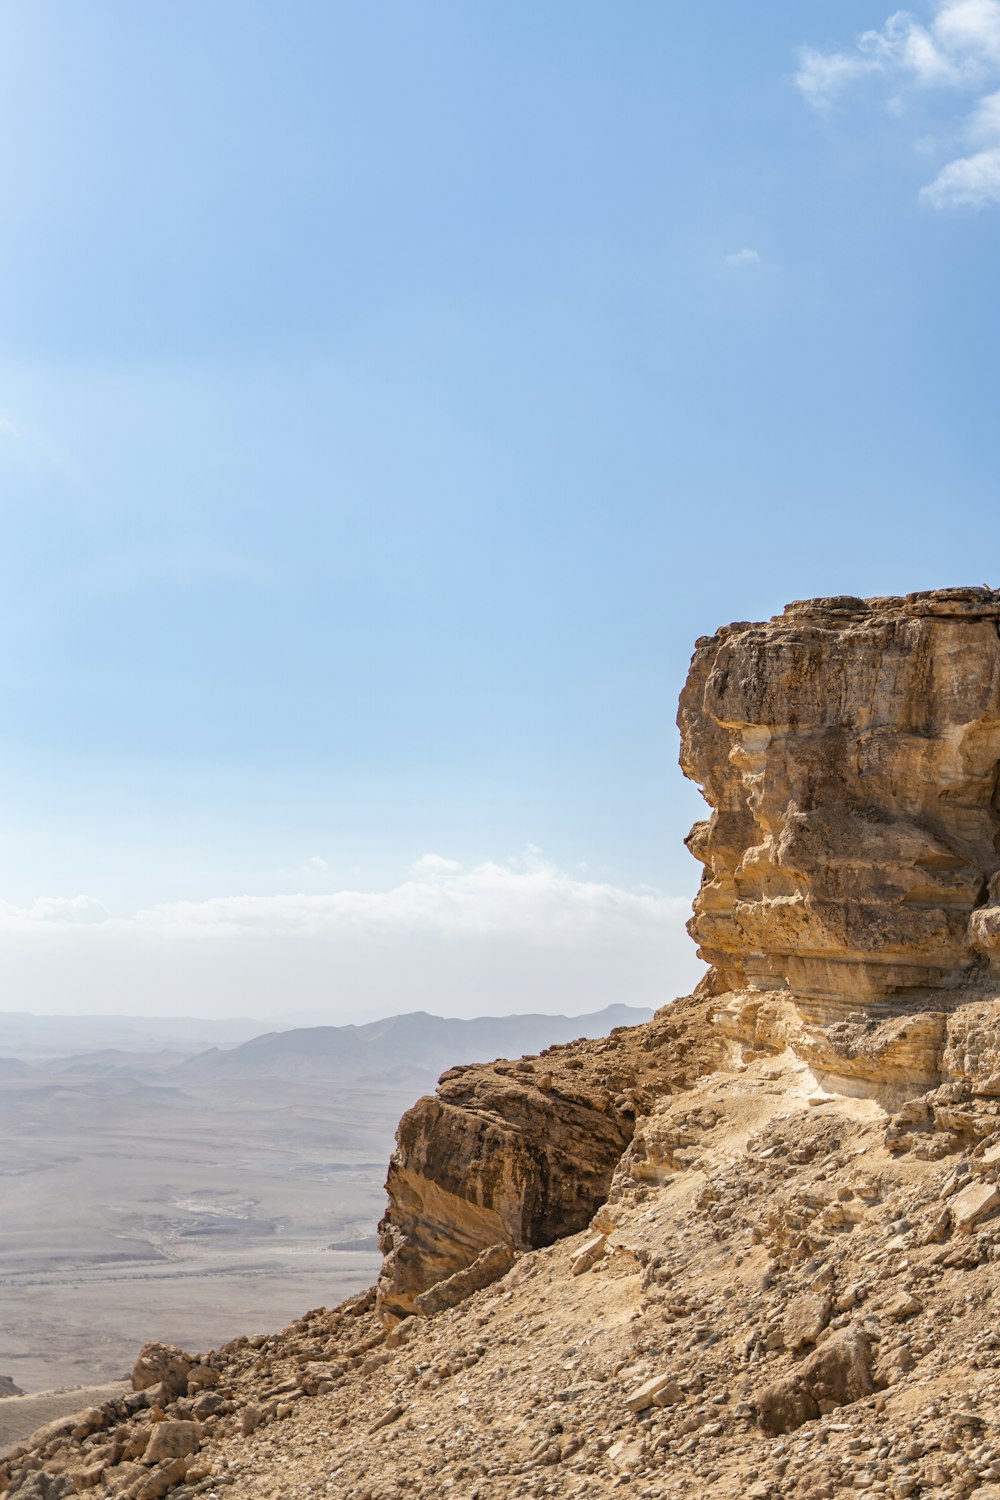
[379,588,1000,1320]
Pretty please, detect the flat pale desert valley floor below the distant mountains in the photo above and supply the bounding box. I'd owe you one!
[0,1074,414,1391]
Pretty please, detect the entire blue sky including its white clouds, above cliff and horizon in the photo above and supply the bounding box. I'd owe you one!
[0,0,1000,1022]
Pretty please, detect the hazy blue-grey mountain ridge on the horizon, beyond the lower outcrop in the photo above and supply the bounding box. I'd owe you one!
[171,1005,654,1083]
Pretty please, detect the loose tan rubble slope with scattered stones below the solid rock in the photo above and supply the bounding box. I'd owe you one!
[9,1002,1000,1500]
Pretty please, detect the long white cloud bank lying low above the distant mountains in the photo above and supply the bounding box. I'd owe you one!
[0,852,700,1023]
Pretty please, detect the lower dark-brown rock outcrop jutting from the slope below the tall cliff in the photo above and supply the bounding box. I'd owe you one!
[379,1001,721,1323]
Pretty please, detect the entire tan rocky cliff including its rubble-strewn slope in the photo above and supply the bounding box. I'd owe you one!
[9,590,1000,1500]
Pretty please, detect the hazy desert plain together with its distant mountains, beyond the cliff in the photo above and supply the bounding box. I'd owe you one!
[0,1008,650,1392]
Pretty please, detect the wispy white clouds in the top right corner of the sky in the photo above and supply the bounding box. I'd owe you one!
[796,0,1000,209]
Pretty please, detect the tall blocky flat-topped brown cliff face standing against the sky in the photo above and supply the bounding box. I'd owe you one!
[679,588,1000,1020]
